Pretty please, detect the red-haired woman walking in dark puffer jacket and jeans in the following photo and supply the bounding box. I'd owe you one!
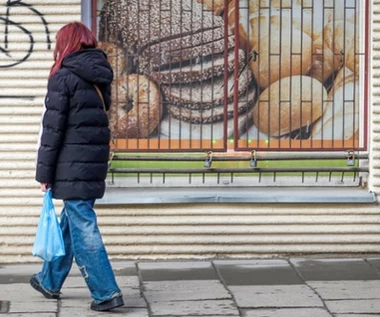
[30,22,124,311]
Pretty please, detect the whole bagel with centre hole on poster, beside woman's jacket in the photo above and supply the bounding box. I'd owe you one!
[110,74,162,139]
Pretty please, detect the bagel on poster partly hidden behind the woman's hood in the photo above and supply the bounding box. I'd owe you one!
[98,41,131,75]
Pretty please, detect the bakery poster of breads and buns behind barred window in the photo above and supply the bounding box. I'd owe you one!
[96,0,368,151]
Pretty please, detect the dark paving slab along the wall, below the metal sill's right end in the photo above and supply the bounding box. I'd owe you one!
[290,259,380,281]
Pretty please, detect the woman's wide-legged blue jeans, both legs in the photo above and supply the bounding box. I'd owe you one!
[37,200,121,304]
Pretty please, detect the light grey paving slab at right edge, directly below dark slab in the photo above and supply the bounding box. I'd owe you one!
[308,280,380,300]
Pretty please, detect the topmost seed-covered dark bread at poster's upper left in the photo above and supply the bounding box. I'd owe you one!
[99,0,223,53]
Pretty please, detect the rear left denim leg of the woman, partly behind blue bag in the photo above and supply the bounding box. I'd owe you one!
[37,208,73,293]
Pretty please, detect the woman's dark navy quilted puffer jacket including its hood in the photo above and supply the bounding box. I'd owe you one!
[36,49,113,200]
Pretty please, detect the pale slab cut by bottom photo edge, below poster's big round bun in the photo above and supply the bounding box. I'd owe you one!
[243,308,332,317]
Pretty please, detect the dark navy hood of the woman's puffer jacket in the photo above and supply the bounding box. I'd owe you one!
[62,48,113,85]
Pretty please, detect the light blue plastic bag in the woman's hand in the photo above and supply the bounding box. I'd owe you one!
[32,189,65,262]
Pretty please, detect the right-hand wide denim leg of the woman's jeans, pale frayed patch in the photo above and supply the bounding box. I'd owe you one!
[65,200,121,304]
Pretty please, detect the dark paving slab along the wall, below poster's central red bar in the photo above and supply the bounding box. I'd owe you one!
[214,260,304,285]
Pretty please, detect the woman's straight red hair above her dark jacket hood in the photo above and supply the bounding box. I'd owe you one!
[49,22,97,77]
